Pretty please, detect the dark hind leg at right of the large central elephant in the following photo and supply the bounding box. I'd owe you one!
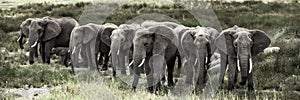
[163,56,176,86]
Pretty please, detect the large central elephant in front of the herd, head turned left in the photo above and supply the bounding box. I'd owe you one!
[132,25,178,92]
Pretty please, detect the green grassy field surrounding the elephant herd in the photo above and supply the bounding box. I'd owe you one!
[0,0,300,100]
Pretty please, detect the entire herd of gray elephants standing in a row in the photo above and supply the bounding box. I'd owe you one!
[18,17,271,92]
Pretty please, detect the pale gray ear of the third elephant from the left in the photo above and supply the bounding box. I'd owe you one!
[82,26,98,44]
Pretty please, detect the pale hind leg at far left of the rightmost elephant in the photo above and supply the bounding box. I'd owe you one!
[219,51,228,84]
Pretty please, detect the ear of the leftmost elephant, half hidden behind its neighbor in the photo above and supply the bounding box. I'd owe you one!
[20,18,34,37]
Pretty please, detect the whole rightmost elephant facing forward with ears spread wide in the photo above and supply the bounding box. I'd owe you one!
[216,26,271,91]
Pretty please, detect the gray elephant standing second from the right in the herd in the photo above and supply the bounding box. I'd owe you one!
[181,27,219,85]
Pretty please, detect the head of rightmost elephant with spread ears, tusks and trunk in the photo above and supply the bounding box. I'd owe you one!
[216,26,271,81]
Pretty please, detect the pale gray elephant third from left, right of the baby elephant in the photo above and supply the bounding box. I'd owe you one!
[69,23,118,72]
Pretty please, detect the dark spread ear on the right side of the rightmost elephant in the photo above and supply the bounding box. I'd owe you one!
[249,30,271,56]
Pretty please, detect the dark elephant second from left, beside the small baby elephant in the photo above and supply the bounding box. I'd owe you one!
[29,17,78,64]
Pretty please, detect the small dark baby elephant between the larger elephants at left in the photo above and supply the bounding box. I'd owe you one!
[50,47,70,67]
